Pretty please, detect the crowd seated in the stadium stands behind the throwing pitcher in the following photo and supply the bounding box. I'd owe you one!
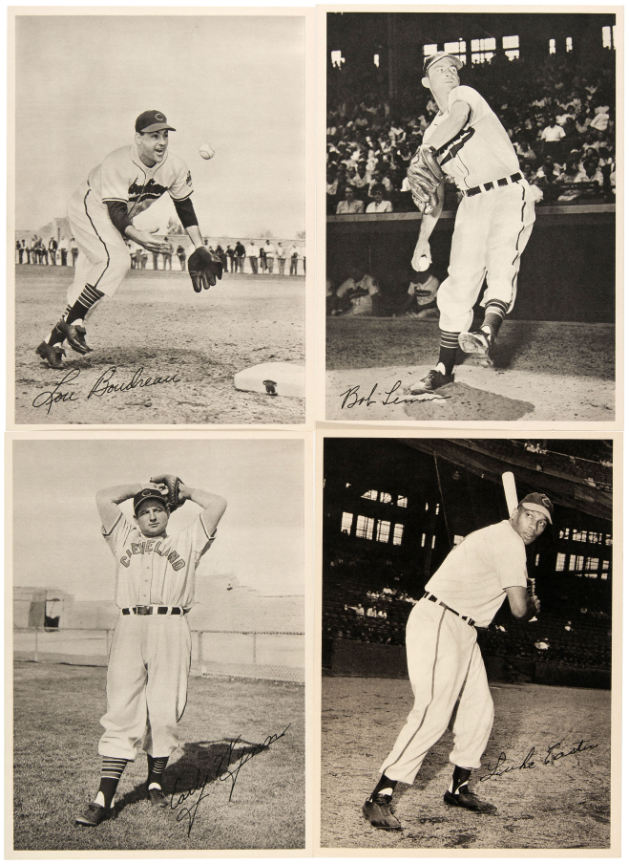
[326,49,616,214]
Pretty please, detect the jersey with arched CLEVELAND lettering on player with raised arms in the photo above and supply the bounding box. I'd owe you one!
[103,512,216,609]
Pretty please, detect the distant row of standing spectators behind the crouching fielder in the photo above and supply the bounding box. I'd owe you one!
[15,234,306,276]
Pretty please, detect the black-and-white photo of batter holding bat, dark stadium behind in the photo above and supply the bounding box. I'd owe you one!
[320,431,622,856]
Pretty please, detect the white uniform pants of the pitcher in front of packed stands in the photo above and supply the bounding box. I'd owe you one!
[437,182,535,333]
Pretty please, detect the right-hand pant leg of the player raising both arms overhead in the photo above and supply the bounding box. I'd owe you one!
[143,615,192,756]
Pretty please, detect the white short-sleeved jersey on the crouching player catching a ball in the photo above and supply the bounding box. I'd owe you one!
[87,145,193,218]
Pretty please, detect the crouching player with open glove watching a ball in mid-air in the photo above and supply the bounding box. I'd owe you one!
[36,111,222,369]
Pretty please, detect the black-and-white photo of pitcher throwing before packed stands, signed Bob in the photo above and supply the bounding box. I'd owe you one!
[326,6,622,425]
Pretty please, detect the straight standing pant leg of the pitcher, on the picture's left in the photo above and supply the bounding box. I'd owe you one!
[437,194,491,333]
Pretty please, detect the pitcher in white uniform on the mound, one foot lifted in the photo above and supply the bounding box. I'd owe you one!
[408,51,535,393]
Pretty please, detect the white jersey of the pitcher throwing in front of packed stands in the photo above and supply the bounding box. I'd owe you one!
[423,84,520,190]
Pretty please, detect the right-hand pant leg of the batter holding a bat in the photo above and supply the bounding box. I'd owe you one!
[450,644,494,769]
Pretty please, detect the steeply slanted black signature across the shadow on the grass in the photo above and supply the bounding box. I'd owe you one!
[170,723,291,837]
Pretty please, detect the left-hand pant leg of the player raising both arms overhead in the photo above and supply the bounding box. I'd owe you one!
[98,615,148,759]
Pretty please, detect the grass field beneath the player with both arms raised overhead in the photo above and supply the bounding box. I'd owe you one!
[13,662,305,851]
